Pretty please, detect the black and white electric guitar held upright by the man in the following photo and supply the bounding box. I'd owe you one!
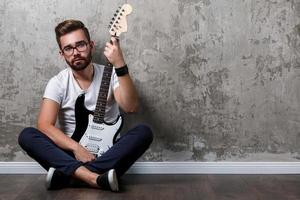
[71,4,132,157]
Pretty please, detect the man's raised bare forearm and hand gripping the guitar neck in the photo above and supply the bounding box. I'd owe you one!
[104,37,139,113]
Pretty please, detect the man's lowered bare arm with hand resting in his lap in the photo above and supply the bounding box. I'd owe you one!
[37,99,95,162]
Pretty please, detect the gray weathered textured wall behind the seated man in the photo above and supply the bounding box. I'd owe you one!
[0,0,300,161]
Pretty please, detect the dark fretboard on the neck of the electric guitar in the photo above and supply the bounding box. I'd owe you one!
[93,63,113,124]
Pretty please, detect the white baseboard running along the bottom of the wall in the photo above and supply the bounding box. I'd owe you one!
[0,162,300,174]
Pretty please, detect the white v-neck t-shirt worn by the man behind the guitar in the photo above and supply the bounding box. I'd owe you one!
[43,63,120,136]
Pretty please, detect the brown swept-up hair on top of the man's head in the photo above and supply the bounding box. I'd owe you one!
[55,19,91,48]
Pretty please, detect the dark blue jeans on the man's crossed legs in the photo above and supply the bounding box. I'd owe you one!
[19,125,153,177]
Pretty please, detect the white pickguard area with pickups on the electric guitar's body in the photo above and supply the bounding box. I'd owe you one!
[79,114,123,157]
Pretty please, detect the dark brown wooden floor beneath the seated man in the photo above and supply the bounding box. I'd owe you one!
[0,175,300,200]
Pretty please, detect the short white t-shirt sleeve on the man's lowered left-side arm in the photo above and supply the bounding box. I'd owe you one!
[43,77,63,104]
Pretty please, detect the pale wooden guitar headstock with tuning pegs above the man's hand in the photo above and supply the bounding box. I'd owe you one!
[109,4,132,37]
